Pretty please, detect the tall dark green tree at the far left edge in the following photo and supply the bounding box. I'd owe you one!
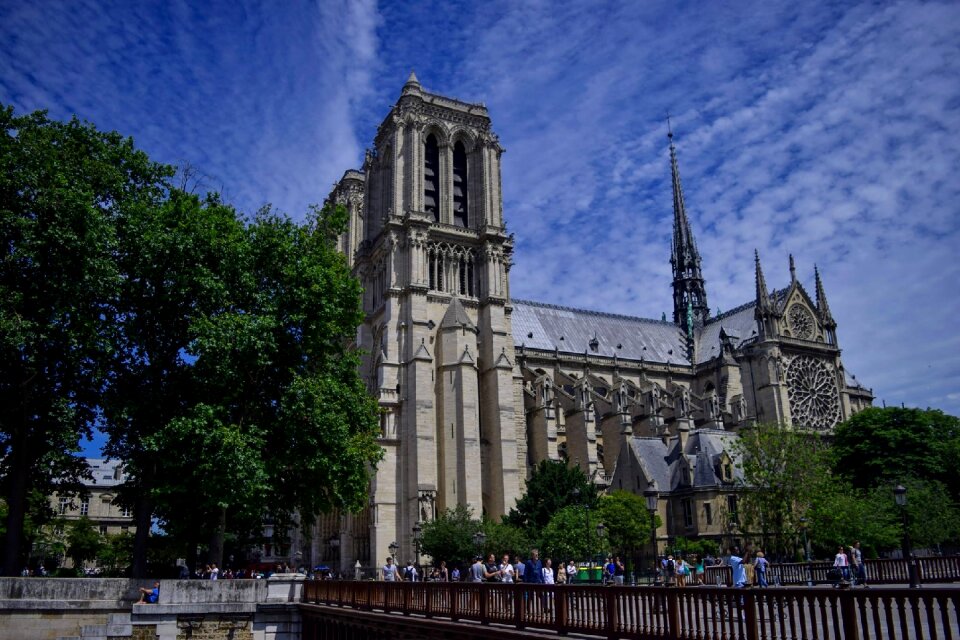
[0,106,171,575]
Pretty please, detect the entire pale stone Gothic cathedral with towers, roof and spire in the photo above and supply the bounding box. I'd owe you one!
[318,74,872,571]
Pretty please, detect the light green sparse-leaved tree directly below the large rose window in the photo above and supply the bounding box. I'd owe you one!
[734,424,830,553]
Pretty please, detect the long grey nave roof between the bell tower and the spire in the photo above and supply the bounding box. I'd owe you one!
[511,299,690,366]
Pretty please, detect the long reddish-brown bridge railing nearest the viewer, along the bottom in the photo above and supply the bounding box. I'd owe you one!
[303,581,960,640]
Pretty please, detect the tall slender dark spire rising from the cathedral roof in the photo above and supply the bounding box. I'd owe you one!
[667,123,710,332]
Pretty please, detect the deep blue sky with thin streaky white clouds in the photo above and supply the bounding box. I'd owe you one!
[0,0,960,456]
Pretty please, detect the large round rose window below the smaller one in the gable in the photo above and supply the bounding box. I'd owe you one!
[787,356,840,431]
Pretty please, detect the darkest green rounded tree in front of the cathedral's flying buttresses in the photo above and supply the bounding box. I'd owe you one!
[506,460,598,538]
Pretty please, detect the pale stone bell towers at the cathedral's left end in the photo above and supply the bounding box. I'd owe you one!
[330,73,525,562]
